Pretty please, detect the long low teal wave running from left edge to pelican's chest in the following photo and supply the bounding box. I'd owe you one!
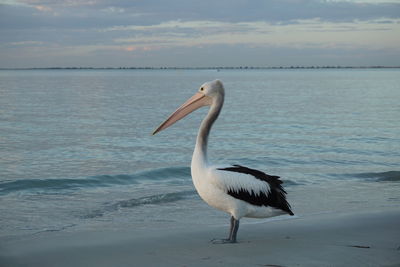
[0,167,190,195]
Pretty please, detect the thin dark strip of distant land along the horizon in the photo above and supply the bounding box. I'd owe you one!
[0,66,400,70]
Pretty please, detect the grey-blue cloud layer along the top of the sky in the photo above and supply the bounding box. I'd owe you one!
[0,0,400,33]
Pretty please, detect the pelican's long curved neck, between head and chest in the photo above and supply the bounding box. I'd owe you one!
[192,95,224,167]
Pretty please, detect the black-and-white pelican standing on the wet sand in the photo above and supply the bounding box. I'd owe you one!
[153,80,293,243]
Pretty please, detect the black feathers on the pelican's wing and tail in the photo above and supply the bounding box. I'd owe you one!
[218,165,294,215]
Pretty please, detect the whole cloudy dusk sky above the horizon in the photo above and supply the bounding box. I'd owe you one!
[0,0,400,68]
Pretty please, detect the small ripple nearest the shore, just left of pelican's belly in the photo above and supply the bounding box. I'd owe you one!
[83,190,196,219]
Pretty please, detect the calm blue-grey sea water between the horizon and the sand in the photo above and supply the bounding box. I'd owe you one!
[0,69,400,240]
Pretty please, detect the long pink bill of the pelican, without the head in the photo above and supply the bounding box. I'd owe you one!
[153,92,211,135]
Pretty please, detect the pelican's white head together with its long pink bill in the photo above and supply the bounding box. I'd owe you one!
[153,80,225,135]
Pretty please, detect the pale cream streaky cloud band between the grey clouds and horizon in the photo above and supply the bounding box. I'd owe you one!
[107,19,400,49]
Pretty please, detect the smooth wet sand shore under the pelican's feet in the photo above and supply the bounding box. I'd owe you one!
[0,209,400,267]
